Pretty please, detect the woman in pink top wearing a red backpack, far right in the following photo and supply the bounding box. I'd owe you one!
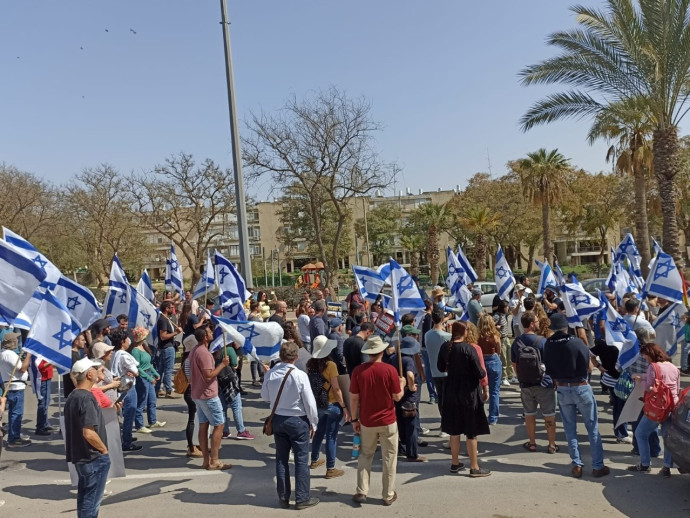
[628,343,680,478]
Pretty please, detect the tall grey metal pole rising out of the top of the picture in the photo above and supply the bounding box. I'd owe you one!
[220,0,254,288]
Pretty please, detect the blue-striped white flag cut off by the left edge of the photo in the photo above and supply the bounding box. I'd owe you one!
[0,241,46,323]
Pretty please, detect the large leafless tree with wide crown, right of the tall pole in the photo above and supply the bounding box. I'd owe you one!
[242,87,397,288]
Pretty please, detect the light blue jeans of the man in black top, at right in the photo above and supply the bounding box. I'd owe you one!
[558,385,604,469]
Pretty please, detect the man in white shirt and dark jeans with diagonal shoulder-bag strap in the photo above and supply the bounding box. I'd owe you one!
[261,342,319,509]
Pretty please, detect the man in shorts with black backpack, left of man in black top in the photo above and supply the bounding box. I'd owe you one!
[510,311,559,454]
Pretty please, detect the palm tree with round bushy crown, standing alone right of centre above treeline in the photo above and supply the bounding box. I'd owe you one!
[509,148,570,261]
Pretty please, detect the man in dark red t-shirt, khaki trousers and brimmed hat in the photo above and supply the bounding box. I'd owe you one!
[350,335,406,505]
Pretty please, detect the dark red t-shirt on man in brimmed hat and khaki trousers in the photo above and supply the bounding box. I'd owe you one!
[350,362,400,428]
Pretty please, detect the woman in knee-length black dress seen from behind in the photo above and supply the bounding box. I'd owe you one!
[437,322,491,477]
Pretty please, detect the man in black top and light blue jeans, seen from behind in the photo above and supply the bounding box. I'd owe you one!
[542,313,611,478]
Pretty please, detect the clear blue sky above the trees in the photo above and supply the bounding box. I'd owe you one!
[0,0,610,198]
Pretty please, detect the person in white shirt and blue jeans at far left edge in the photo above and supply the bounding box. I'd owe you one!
[0,332,31,448]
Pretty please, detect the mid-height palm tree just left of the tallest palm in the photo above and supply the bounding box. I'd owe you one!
[587,97,654,278]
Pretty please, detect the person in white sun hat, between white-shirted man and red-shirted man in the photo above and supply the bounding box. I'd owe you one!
[307,335,350,478]
